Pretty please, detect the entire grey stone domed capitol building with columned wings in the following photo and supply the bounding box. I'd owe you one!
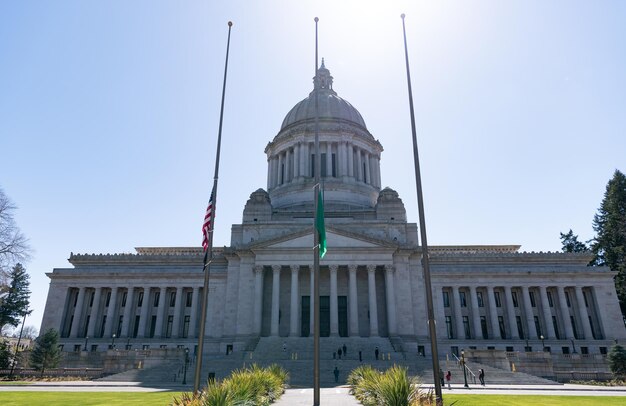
[41,59,626,364]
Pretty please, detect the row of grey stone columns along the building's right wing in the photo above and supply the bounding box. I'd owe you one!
[451,286,593,339]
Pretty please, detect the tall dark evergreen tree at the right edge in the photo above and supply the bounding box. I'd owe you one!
[591,170,626,316]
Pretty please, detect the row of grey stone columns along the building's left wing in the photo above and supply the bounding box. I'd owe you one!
[66,286,200,338]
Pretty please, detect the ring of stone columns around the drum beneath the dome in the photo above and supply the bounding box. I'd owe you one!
[267,141,381,189]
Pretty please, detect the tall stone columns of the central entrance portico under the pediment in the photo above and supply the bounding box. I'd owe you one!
[254,264,397,336]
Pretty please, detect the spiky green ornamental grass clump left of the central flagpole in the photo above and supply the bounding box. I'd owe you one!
[173,364,289,406]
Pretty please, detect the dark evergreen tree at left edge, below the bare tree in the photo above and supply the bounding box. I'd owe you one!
[0,263,30,327]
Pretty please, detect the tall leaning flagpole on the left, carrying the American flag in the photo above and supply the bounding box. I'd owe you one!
[193,21,233,393]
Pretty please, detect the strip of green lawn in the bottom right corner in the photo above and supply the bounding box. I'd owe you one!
[443,393,626,406]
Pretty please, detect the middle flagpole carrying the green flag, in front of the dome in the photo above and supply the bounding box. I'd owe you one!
[313,17,322,406]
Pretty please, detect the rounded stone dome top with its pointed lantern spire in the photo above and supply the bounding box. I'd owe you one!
[280,59,367,130]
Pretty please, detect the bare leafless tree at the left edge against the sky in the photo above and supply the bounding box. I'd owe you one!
[0,188,30,293]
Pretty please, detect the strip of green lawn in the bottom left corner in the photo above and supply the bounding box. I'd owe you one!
[0,392,180,406]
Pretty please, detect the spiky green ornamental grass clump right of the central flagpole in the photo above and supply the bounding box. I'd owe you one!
[348,365,434,406]
